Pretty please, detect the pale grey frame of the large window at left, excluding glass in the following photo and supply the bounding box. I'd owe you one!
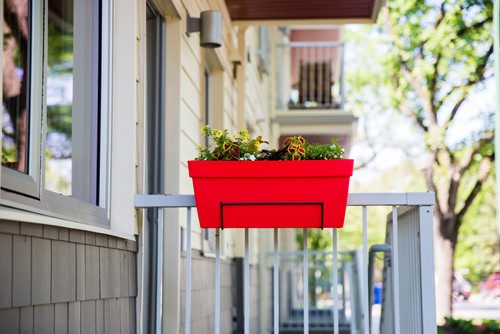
[0,0,113,228]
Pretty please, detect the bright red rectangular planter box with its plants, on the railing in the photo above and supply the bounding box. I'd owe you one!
[188,126,353,228]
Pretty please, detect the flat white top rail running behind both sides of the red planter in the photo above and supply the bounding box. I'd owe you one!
[135,192,435,209]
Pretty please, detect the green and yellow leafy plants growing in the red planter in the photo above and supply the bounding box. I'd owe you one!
[196,125,344,161]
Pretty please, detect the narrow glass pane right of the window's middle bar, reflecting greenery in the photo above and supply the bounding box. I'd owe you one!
[45,0,74,195]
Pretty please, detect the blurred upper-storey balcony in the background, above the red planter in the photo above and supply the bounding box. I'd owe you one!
[274,36,356,149]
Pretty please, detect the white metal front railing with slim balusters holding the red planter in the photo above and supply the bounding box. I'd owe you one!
[135,193,436,334]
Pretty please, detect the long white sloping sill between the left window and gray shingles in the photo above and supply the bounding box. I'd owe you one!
[0,205,136,241]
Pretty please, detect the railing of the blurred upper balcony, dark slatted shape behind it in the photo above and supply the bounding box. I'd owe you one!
[276,42,345,110]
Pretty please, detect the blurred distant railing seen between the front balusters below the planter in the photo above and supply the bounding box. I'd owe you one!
[265,250,362,333]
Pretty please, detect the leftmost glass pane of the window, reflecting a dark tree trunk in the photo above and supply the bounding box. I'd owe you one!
[2,0,30,174]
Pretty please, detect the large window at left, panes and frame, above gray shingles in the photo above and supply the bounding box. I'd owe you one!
[1,0,107,224]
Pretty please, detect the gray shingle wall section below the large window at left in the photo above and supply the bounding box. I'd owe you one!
[0,221,137,333]
